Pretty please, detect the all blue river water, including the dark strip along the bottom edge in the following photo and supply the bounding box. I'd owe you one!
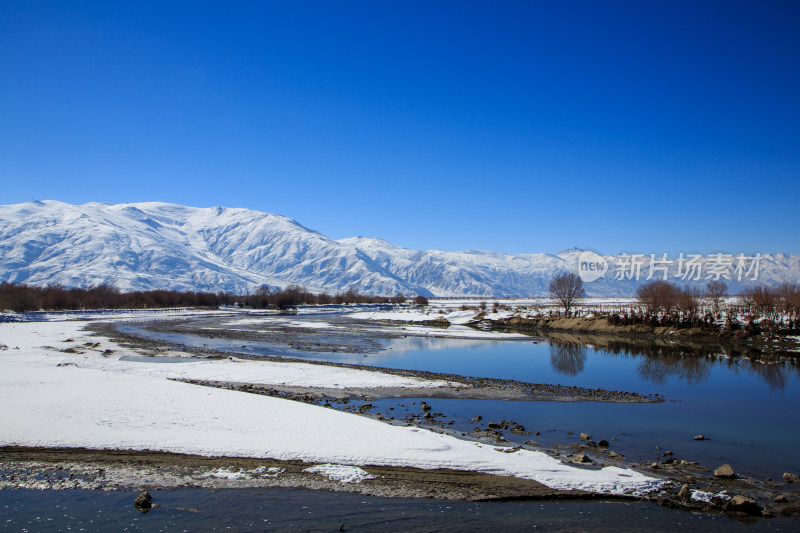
[0,317,800,532]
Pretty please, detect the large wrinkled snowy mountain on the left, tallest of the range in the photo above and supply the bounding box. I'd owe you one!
[0,201,422,294]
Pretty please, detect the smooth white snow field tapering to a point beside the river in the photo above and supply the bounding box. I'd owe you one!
[0,321,663,494]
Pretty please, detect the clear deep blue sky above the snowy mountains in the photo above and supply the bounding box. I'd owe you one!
[0,0,800,253]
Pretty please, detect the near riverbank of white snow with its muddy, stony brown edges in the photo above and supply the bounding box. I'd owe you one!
[0,312,798,516]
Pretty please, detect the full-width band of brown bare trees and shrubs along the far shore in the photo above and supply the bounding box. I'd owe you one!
[0,281,800,341]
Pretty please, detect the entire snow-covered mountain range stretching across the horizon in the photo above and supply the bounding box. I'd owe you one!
[0,201,800,297]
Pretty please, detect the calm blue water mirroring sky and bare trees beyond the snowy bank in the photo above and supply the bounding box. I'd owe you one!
[122,317,800,478]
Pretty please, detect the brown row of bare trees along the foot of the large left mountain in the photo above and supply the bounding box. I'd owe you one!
[0,282,428,313]
